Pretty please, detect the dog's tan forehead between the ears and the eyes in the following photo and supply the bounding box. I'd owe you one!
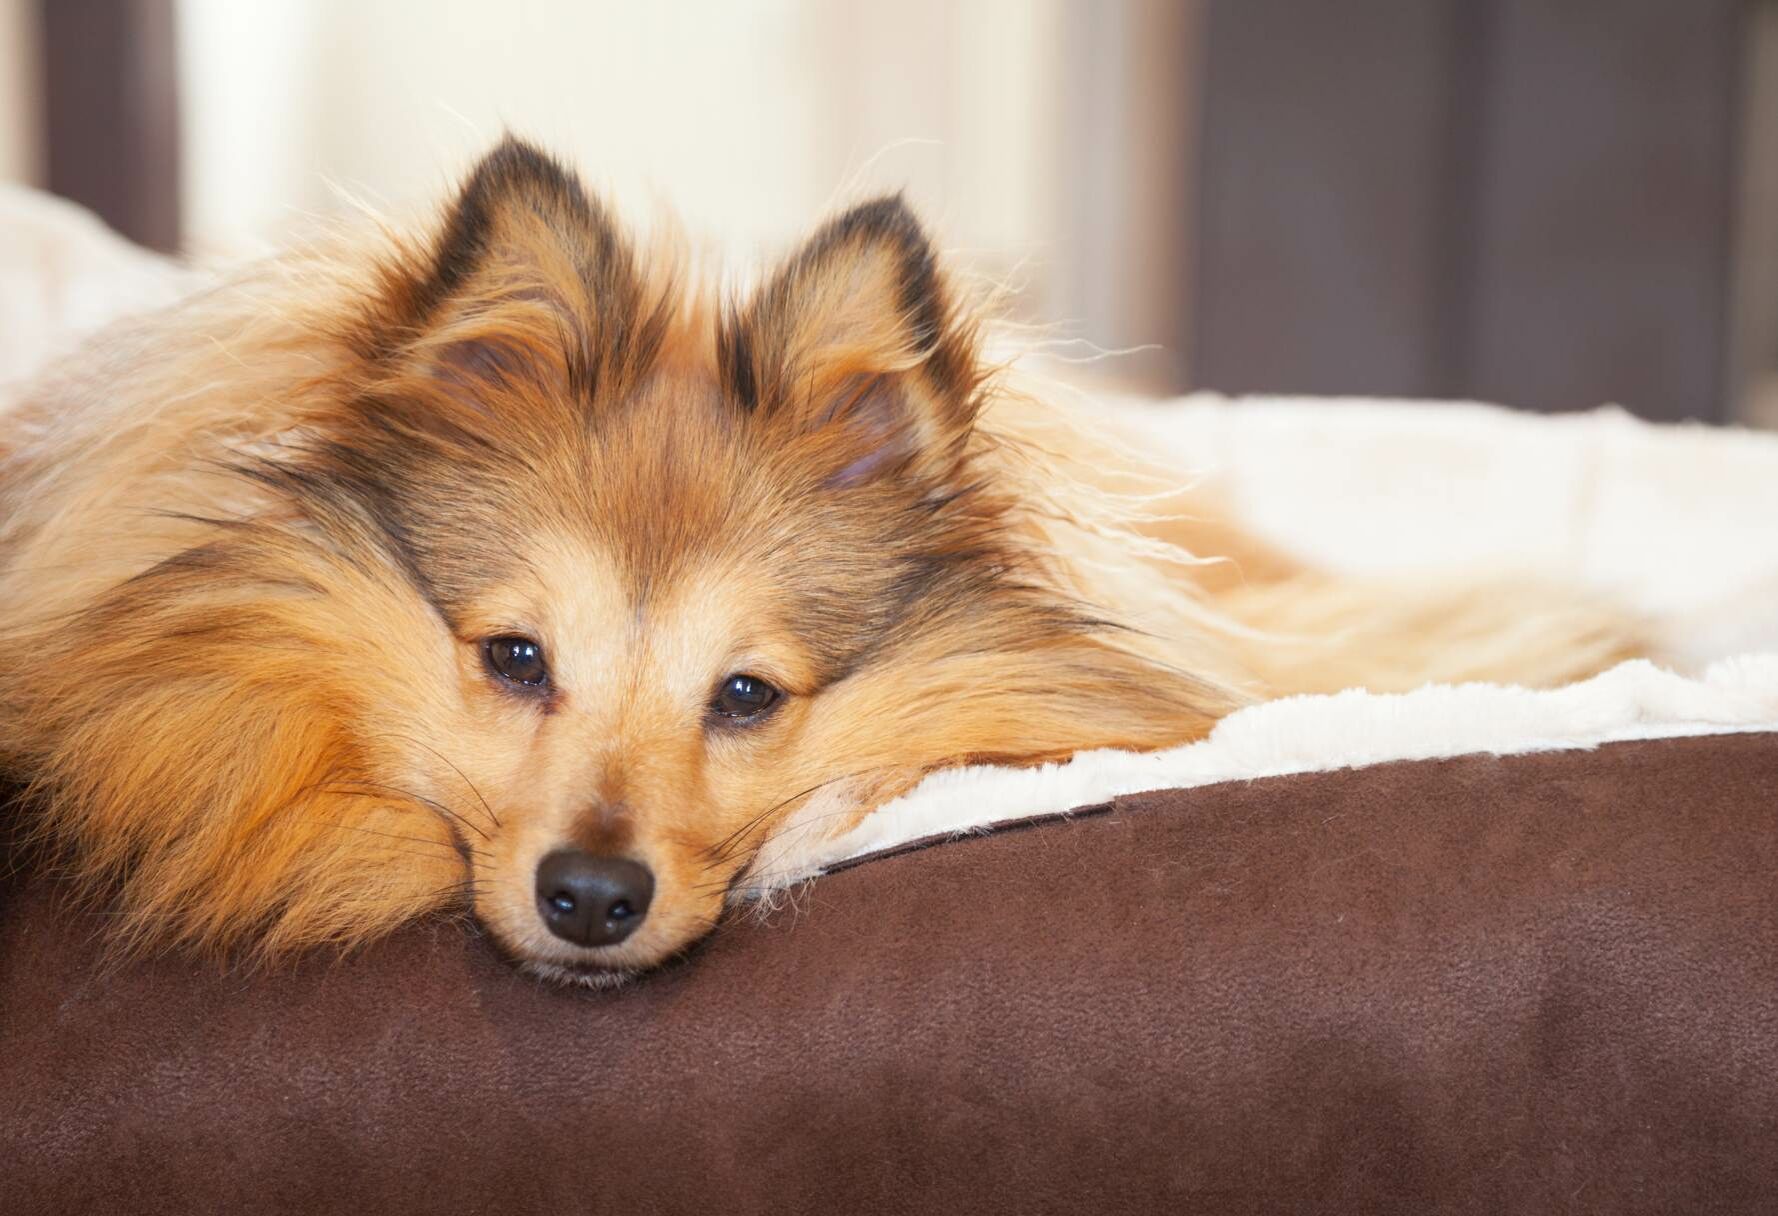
[458,366,919,686]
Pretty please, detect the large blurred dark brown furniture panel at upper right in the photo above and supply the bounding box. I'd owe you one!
[1181,0,1751,421]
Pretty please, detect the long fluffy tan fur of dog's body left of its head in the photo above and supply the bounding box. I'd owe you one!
[0,280,473,955]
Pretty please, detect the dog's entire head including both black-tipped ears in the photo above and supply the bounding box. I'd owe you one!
[270,146,1130,974]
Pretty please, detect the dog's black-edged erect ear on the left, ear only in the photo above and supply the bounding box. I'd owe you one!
[361,135,649,403]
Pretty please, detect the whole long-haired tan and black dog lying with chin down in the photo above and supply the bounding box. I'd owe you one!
[0,139,1641,983]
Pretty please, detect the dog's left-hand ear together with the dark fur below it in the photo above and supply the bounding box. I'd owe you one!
[263,137,672,612]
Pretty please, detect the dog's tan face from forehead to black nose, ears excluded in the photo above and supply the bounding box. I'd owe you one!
[375,360,1017,974]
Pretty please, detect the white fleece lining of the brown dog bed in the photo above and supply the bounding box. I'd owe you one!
[0,188,1778,885]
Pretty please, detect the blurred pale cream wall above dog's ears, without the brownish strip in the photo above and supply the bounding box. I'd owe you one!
[180,0,1060,277]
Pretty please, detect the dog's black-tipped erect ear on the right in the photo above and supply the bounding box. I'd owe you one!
[718,196,980,485]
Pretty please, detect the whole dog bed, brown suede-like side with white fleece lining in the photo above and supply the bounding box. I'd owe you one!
[10,184,1778,1214]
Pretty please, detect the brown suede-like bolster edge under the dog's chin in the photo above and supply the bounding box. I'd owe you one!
[0,734,1778,1216]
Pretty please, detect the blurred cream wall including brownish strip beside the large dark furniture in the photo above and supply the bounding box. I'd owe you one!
[169,0,1202,388]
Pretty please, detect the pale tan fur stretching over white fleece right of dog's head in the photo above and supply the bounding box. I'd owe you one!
[987,394,1652,700]
